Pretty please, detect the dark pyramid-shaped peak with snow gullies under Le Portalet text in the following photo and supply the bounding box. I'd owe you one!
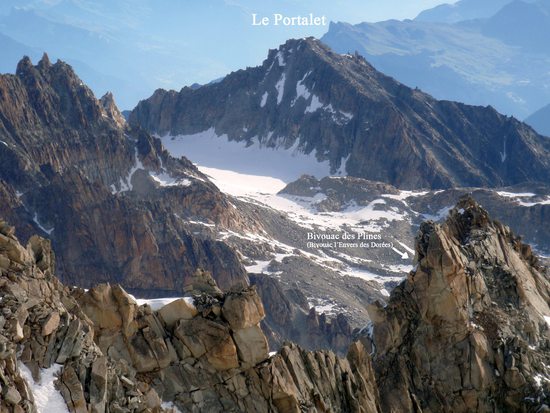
[130,38,550,188]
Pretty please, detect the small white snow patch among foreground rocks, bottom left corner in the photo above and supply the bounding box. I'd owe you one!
[17,362,69,413]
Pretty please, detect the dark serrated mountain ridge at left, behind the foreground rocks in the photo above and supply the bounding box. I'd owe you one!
[0,56,252,294]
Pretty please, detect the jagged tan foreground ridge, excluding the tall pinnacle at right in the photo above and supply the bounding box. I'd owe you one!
[0,217,380,413]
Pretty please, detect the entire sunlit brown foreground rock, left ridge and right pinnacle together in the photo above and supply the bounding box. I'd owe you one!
[0,197,550,413]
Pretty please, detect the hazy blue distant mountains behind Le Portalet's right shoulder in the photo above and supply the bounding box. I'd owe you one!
[322,0,550,119]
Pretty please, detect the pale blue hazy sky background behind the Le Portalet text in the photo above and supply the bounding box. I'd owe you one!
[0,0,458,109]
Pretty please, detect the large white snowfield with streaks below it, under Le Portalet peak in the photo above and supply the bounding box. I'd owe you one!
[161,130,425,295]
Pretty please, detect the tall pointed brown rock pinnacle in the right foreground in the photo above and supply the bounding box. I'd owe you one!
[365,198,550,412]
